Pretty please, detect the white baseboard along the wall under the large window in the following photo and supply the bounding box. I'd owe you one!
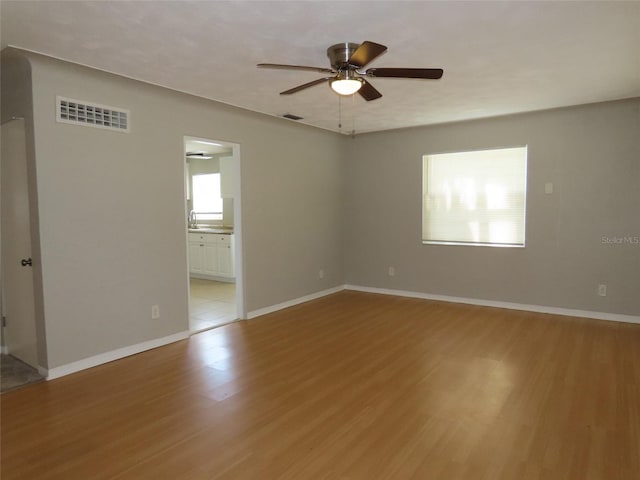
[344,285,640,323]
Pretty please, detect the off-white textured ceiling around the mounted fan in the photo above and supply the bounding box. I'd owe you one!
[0,0,640,133]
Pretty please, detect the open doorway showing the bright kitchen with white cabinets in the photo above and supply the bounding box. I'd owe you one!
[184,136,246,334]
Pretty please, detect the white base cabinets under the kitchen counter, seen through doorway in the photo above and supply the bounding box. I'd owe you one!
[189,233,235,280]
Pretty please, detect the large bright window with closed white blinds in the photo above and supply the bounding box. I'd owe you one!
[422,146,527,247]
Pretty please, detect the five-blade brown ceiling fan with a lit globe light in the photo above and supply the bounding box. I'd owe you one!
[258,41,443,101]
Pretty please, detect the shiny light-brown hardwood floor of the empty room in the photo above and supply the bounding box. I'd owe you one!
[1,292,640,480]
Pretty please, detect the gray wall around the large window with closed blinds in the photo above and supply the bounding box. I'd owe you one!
[345,99,640,315]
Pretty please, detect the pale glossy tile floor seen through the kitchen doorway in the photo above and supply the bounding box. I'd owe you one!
[189,278,237,332]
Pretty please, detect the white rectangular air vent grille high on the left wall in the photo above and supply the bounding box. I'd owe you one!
[56,97,130,133]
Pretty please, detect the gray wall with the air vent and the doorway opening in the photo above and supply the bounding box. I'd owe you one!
[12,49,345,368]
